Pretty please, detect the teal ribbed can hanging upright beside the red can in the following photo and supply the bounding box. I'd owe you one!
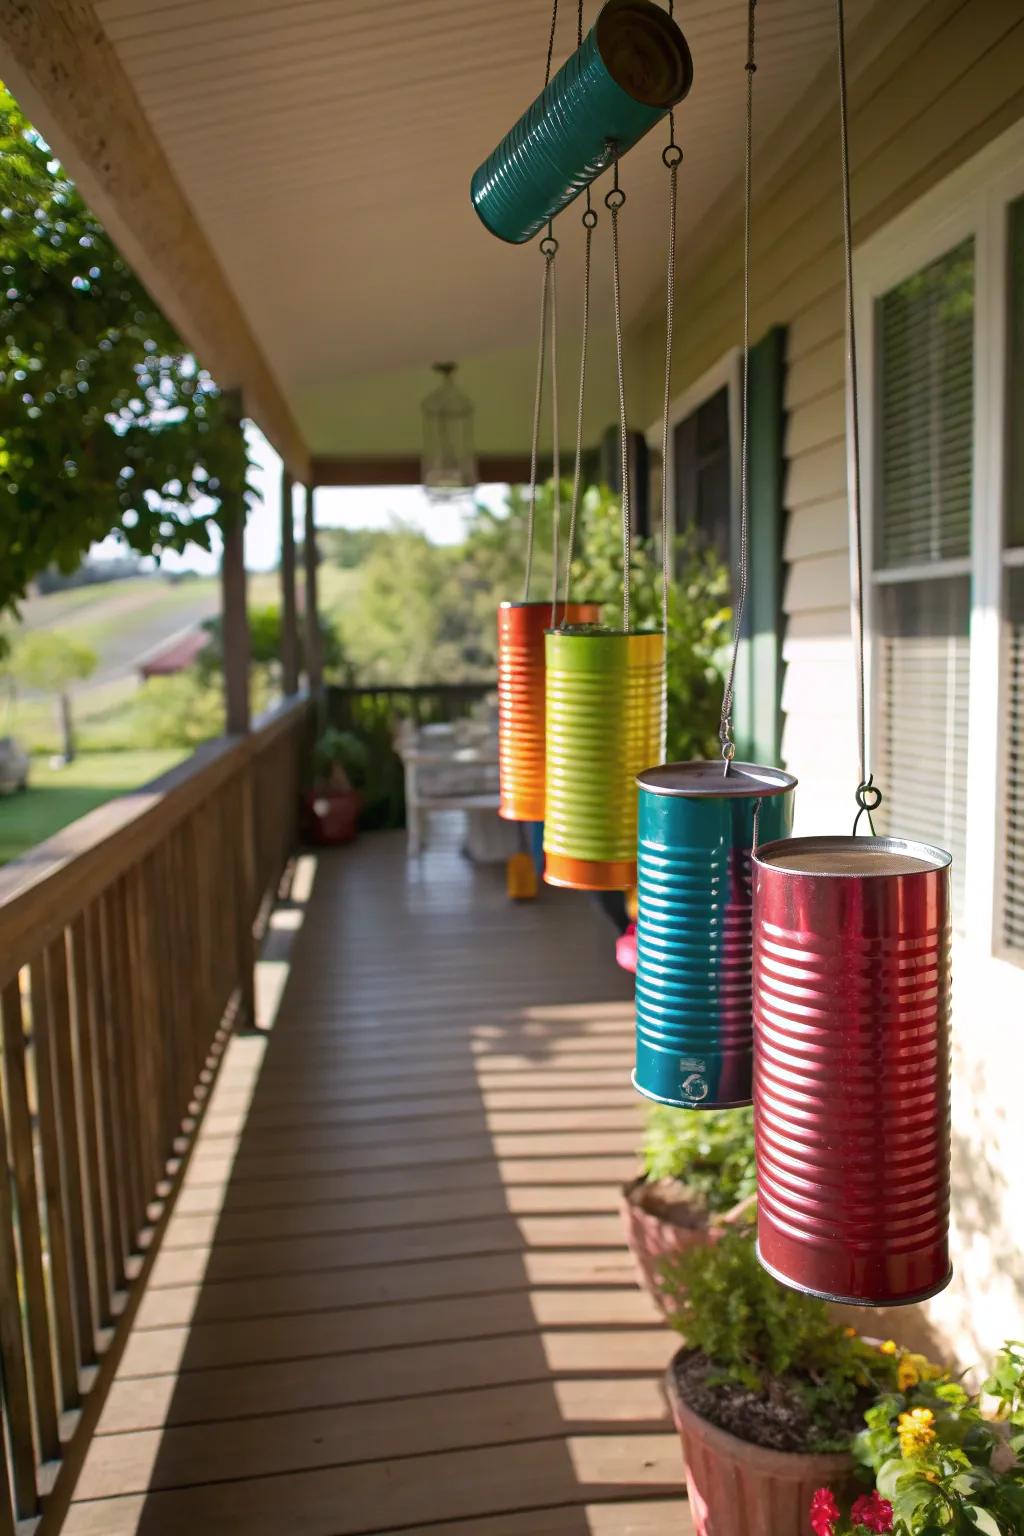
[633,760,797,1109]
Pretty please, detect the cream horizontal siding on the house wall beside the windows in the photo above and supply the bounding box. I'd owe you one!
[633,0,1024,1362]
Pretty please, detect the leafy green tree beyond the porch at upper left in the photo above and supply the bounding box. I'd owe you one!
[0,86,252,611]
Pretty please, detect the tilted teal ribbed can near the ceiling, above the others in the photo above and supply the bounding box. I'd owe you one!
[470,0,694,244]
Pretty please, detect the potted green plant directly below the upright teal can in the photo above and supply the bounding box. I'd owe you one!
[619,1104,757,1312]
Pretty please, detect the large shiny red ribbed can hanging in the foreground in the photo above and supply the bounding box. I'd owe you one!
[754,837,950,1306]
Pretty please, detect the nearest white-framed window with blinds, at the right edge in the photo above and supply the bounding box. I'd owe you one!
[855,123,1024,958]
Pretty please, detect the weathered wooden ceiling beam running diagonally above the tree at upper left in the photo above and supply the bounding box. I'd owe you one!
[0,0,310,481]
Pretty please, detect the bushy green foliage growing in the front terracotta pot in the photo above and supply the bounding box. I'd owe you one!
[663,1229,895,1450]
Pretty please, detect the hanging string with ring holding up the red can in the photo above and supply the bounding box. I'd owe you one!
[835,0,881,836]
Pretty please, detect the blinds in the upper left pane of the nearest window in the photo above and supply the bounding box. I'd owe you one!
[875,240,973,570]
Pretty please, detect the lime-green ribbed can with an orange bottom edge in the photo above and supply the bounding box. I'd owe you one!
[543,628,665,891]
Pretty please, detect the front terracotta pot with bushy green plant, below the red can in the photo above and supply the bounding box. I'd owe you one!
[665,1227,900,1536]
